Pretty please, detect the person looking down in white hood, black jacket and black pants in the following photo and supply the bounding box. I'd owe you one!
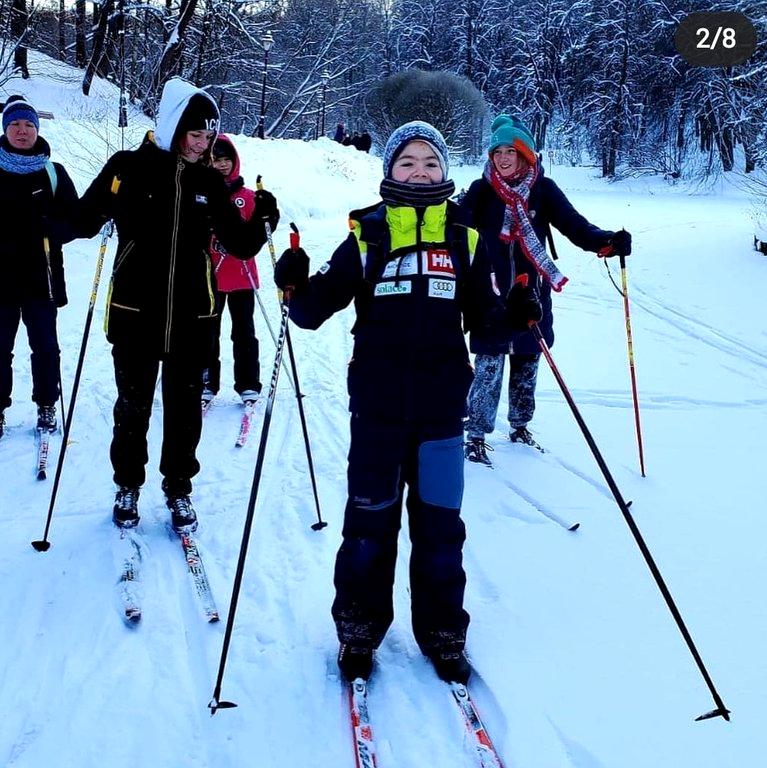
[75,78,278,533]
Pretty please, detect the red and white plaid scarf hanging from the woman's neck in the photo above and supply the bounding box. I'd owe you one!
[483,160,567,291]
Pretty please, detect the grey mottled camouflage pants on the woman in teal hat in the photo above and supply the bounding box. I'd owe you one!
[466,355,540,438]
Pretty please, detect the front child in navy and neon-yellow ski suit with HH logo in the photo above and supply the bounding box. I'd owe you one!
[274,121,536,682]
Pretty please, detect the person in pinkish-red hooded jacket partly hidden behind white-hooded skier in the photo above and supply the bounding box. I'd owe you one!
[202,134,277,406]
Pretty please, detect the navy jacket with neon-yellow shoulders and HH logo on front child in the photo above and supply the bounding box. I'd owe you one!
[290,203,490,422]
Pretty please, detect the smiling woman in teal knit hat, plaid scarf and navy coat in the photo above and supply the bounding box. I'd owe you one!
[460,115,631,465]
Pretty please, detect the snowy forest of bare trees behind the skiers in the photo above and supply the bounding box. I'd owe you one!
[0,0,767,180]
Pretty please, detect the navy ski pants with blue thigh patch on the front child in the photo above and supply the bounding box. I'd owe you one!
[332,414,469,654]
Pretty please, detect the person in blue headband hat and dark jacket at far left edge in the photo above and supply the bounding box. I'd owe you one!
[0,96,77,437]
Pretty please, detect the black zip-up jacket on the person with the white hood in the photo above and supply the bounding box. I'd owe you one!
[80,132,266,355]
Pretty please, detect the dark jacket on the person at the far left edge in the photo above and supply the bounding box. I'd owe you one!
[0,136,77,307]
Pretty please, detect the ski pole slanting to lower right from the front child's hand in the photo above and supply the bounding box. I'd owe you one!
[530,323,730,720]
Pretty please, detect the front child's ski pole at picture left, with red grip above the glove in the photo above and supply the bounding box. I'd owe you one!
[208,224,327,715]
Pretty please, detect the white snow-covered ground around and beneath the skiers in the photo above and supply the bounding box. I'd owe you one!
[0,57,767,768]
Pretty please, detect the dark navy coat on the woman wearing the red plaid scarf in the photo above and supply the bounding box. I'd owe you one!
[460,165,613,355]
